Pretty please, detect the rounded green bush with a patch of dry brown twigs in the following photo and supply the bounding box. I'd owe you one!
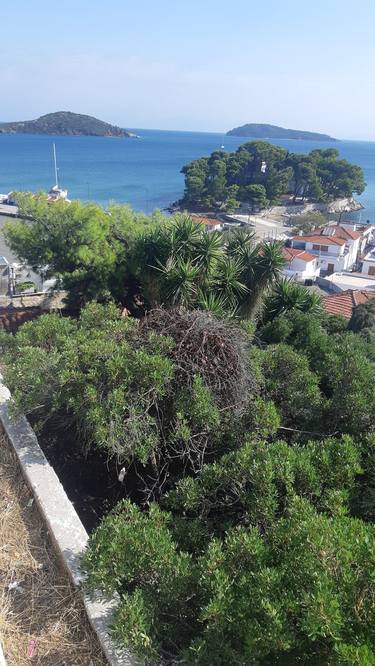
[1,304,259,498]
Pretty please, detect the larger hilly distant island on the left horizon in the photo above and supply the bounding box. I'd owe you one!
[0,111,136,137]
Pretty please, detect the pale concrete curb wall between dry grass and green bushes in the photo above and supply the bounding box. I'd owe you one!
[0,375,139,666]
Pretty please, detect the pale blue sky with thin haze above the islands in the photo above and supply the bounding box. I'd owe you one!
[0,0,375,140]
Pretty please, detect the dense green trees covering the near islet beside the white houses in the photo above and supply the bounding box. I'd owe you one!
[180,141,365,210]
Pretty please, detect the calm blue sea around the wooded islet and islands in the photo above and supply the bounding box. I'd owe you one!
[0,129,375,222]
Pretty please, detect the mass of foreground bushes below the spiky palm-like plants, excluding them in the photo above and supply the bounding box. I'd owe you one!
[0,290,375,666]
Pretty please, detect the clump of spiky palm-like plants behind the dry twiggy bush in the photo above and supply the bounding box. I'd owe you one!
[139,214,284,319]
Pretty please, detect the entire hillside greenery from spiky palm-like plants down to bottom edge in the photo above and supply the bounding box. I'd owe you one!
[0,199,375,666]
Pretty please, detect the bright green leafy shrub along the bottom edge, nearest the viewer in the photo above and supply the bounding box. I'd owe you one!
[85,498,375,666]
